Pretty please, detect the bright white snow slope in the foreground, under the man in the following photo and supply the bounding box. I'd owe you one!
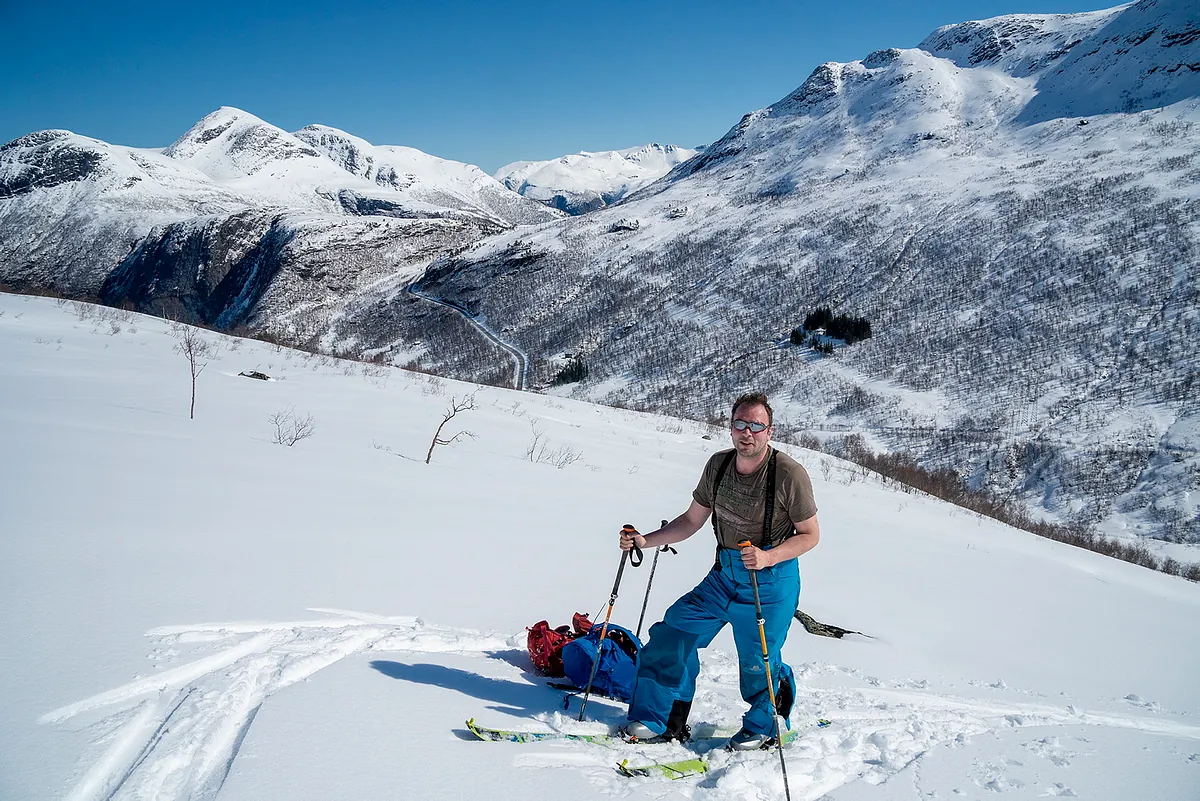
[0,295,1200,801]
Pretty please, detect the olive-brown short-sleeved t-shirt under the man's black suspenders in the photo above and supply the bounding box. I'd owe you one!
[691,448,817,548]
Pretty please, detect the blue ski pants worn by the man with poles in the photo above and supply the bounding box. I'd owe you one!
[629,548,800,734]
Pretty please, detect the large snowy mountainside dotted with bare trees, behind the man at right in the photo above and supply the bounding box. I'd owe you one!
[400,0,1200,540]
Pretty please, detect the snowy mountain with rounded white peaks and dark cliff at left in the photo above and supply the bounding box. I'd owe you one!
[0,108,562,345]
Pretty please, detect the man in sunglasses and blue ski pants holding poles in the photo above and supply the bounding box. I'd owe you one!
[620,393,821,749]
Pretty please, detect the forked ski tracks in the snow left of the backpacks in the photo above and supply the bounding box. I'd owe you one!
[40,609,509,801]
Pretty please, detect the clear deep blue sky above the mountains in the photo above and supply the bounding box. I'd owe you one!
[0,0,1117,171]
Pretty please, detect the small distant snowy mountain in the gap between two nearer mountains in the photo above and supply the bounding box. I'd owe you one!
[494,143,703,215]
